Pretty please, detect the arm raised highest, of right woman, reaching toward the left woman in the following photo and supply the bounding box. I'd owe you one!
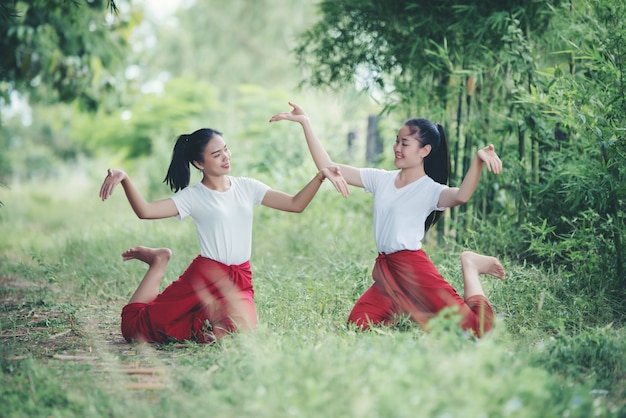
[270,102,363,193]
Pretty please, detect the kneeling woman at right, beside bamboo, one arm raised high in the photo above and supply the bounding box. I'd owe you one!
[270,102,504,336]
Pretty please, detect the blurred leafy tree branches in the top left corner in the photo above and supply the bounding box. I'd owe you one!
[0,0,129,110]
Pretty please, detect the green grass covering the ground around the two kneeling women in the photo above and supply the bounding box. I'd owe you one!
[0,165,626,417]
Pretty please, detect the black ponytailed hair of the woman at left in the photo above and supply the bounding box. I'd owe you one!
[163,128,222,192]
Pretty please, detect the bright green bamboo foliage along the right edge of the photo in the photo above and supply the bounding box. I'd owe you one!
[521,1,626,298]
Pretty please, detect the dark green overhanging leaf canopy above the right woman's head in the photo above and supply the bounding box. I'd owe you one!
[296,0,559,108]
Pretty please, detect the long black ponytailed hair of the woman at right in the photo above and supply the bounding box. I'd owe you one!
[404,118,450,232]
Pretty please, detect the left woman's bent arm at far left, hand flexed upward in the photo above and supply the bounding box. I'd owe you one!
[100,169,178,219]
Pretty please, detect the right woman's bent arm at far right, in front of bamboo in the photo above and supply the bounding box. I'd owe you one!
[437,144,502,208]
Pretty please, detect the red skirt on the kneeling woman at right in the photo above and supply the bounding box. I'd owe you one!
[348,250,494,336]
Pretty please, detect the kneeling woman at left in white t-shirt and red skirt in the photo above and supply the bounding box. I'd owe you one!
[100,129,338,343]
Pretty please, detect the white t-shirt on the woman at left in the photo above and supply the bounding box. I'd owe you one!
[171,176,270,265]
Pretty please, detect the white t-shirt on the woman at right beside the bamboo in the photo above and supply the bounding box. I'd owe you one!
[360,168,448,254]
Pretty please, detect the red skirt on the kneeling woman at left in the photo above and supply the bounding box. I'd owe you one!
[122,256,257,343]
